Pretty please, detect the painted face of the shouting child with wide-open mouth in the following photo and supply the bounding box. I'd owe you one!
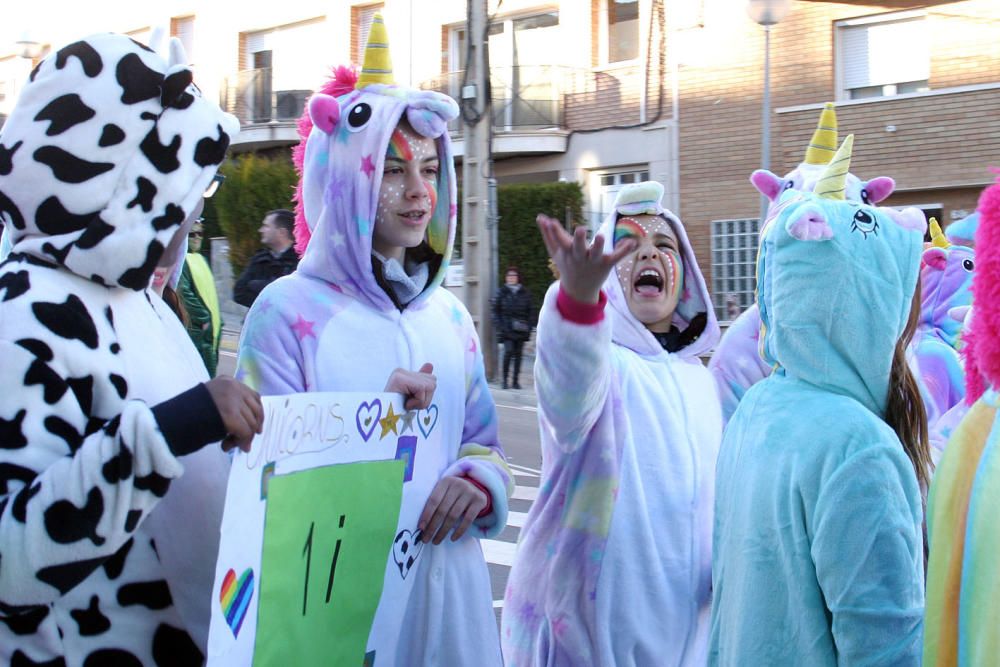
[614,215,684,333]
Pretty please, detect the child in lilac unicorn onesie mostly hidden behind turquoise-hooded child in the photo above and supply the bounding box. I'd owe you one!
[708,102,896,422]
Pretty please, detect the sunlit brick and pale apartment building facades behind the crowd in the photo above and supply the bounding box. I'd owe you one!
[0,0,1000,320]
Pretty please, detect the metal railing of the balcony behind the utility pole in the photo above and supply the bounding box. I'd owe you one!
[420,65,641,133]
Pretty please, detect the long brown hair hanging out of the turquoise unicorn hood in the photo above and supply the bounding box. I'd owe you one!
[885,282,933,493]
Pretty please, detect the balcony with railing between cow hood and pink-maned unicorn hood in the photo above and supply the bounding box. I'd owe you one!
[219,68,312,152]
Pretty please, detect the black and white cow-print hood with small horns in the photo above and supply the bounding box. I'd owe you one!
[0,34,239,290]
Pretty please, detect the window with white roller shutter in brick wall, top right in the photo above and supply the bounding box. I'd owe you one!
[836,12,930,100]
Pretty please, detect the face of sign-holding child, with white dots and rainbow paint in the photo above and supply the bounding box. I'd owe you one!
[372,120,440,262]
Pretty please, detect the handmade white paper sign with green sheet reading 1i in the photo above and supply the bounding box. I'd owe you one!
[208,393,447,667]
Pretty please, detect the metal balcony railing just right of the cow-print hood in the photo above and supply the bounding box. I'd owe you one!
[219,67,313,125]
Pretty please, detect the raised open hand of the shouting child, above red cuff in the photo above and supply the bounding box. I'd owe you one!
[535,213,635,303]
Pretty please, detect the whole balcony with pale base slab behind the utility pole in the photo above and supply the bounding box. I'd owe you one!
[420,65,642,157]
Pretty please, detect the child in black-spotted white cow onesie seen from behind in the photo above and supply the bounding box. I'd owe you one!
[0,34,263,667]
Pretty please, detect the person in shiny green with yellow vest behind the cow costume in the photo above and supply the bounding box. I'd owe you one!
[177,217,222,377]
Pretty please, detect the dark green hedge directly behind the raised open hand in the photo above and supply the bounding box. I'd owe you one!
[497,183,584,309]
